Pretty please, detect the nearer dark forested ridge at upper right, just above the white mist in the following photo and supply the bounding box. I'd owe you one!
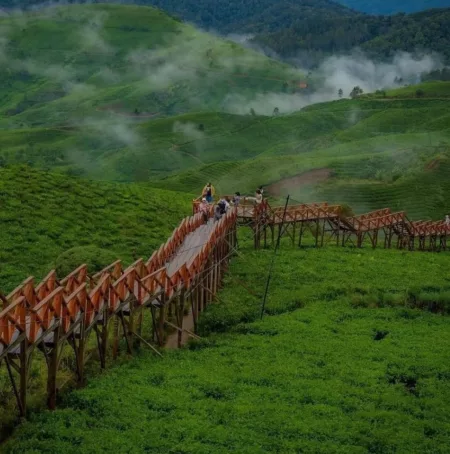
[254,9,450,60]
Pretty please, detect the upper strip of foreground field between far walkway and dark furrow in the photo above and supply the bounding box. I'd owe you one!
[199,238,450,335]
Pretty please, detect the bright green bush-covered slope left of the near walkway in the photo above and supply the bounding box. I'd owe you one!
[0,167,190,293]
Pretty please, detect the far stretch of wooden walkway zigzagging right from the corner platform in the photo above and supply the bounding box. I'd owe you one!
[193,197,450,251]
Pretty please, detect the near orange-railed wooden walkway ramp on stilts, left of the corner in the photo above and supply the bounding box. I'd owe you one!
[0,209,237,416]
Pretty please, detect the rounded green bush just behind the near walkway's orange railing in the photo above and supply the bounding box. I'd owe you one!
[55,246,119,276]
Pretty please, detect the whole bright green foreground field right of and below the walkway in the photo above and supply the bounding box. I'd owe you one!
[4,239,450,453]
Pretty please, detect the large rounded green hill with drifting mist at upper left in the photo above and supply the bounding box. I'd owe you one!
[0,4,302,129]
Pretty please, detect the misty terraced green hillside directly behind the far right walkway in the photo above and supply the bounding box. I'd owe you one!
[153,93,450,218]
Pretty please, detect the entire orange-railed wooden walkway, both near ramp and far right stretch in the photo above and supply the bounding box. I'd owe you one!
[0,199,450,416]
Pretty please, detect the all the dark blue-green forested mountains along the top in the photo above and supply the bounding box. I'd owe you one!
[0,0,450,63]
